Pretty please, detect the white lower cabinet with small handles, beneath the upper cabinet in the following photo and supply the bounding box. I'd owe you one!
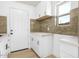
[31,36,52,57]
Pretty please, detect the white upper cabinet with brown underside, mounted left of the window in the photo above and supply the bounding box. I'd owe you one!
[32,1,52,20]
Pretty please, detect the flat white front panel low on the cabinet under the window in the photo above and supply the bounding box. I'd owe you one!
[60,42,78,58]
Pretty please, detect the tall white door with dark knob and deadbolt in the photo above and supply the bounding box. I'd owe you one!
[10,9,29,51]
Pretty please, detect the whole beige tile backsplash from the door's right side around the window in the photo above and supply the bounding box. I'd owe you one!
[31,8,79,35]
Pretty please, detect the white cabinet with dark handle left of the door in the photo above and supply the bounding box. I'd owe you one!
[0,36,8,58]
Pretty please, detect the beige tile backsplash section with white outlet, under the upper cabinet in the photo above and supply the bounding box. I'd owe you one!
[40,17,55,33]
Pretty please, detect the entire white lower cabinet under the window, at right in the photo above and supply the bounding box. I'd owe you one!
[53,34,79,58]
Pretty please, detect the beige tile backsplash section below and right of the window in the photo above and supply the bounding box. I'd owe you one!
[55,8,79,35]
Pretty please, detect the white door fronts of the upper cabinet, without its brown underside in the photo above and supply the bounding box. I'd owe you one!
[36,1,51,18]
